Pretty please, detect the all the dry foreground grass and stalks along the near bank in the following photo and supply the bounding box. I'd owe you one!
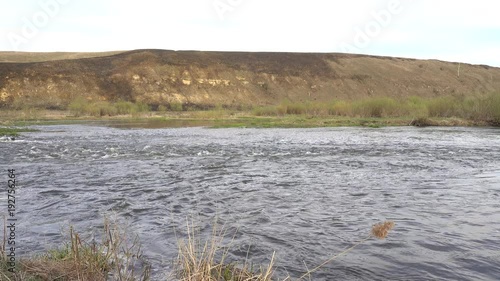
[0,219,394,281]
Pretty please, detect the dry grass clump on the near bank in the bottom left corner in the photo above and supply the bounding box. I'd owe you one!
[0,218,150,281]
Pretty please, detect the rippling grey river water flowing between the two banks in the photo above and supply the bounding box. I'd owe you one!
[0,125,500,280]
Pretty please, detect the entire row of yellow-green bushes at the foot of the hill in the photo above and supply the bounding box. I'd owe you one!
[62,93,500,125]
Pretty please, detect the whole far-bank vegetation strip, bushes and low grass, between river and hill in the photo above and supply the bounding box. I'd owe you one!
[0,92,500,128]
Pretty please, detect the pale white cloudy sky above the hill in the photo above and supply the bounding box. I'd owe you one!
[0,0,500,66]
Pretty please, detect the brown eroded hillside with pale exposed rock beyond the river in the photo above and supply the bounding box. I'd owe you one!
[0,50,500,109]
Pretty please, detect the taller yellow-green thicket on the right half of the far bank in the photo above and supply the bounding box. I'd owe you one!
[253,93,500,124]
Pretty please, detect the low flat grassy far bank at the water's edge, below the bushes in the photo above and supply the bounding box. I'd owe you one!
[0,110,495,132]
